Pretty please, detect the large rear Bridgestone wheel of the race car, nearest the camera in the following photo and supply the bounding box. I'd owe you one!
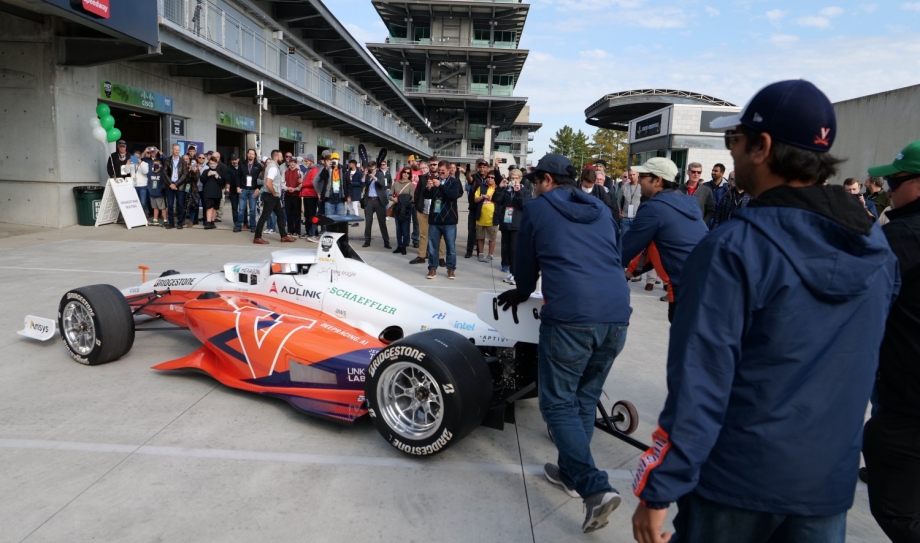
[365,330,492,456]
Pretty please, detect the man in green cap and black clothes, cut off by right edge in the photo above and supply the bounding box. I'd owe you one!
[863,141,920,543]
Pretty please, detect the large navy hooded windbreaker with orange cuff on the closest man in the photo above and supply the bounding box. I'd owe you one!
[633,187,899,516]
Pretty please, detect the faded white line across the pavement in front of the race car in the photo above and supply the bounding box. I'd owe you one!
[0,438,632,480]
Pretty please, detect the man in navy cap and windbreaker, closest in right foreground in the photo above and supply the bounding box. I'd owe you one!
[633,80,898,543]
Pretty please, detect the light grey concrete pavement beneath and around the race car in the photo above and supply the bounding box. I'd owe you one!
[0,216,886,543]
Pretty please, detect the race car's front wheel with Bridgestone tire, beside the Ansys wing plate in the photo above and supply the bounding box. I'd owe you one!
[58,285,134,366]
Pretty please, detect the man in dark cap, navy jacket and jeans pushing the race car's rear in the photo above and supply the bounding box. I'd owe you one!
[498,154,632,533]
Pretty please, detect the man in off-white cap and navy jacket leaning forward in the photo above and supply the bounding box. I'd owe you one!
[623,157,709,321]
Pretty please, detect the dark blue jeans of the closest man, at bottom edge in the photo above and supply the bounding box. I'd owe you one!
[671,492,847,543]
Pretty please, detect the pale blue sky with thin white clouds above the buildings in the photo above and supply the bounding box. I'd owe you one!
[326,0,920,162]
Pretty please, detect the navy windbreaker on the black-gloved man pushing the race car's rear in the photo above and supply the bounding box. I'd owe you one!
[514,187,632,324]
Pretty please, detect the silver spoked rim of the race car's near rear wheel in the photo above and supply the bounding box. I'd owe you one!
[377,362,444,439]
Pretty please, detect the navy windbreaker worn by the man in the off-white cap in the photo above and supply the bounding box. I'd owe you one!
[623,190,709,294]
